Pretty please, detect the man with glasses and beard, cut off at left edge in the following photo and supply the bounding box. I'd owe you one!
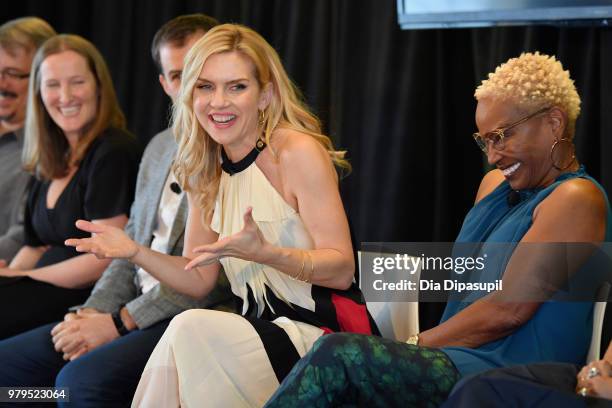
[0,17,55,266]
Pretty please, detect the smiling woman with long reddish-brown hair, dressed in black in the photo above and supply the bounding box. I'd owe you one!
[0,35,141,339]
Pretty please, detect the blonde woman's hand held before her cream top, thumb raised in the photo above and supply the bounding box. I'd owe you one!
[185,207,269,270]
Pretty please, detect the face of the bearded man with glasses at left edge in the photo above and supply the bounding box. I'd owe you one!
[0,47,33,123]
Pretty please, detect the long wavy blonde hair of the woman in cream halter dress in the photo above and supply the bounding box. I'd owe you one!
[173,24,350,220]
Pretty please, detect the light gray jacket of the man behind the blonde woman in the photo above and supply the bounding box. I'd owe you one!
[81,129,231,329]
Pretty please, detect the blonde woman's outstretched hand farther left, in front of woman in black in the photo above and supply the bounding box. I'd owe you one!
[64,220,139,259]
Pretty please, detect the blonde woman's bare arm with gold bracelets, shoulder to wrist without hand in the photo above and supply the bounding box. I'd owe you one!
[262,131,355,289]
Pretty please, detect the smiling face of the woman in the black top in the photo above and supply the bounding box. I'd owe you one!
[40,50,98,141]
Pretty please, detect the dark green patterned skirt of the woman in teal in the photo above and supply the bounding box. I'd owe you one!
[266,333,459,408]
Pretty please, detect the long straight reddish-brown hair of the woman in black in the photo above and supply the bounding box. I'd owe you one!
[22,34,125,180]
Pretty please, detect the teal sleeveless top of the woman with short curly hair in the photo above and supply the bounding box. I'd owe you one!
[441,166,612,375]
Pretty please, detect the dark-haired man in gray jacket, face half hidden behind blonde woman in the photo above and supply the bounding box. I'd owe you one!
[0,14,231,407]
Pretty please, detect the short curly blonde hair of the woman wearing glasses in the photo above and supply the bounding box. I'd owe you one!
[474,51,580,139]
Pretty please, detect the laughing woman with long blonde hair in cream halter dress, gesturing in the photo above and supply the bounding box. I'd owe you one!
[68,24,375,406]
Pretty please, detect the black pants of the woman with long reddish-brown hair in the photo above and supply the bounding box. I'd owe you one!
[0,276,91,340]
